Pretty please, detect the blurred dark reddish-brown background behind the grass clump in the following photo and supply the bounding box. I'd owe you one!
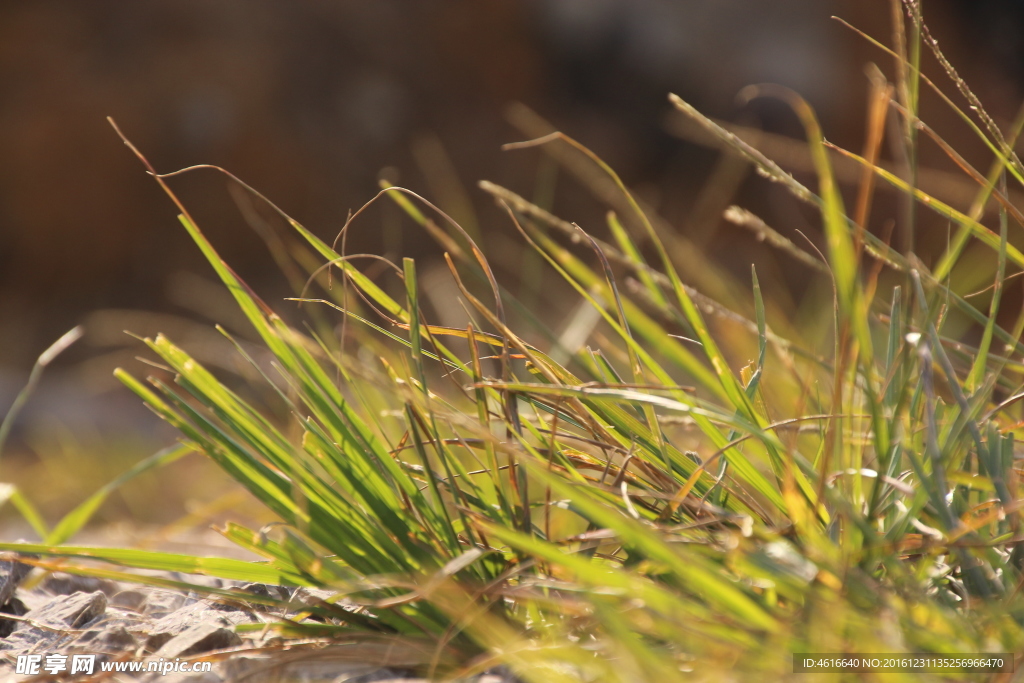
[0,0,1024,532]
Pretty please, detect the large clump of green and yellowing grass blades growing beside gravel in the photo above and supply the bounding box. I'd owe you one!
[0,2,1024,681]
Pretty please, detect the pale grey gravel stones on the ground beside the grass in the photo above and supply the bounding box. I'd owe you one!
[0,561,518,683]
